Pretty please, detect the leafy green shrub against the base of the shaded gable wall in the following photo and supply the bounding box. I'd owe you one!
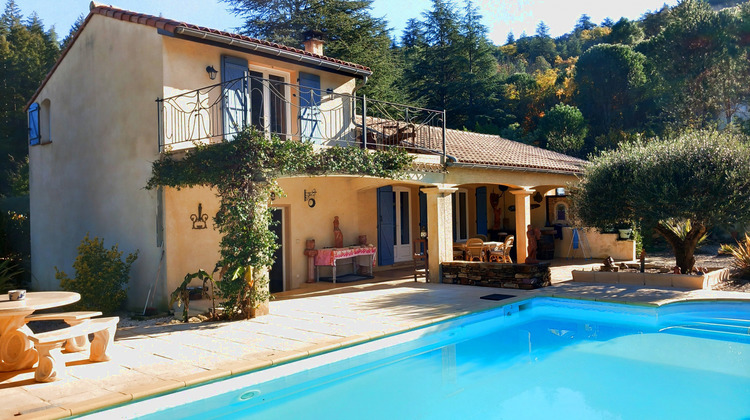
[55,234,138,313]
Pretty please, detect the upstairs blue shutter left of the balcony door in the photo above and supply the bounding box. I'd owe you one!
[221,56,247,139]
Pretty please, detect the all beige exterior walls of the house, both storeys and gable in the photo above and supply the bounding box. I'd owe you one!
[30,11,600,309]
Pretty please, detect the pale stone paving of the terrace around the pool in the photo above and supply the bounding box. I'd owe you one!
[5,261,750,419]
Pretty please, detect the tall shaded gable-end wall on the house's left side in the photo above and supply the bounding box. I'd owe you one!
[29,16,162,308]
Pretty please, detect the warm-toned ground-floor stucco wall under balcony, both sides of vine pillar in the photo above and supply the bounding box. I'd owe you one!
[164,176,428,290]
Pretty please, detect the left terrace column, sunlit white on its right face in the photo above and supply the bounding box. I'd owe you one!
[422,184,458,283]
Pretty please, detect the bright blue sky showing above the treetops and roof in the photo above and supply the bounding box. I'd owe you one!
[17,0,677,44]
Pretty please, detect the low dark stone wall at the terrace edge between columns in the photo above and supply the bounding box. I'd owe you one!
[441,261,552,290]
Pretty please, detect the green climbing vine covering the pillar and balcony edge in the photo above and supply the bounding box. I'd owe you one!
[146,128,413,318]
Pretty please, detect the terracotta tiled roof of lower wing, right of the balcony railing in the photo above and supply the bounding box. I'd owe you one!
[445,130,586,173]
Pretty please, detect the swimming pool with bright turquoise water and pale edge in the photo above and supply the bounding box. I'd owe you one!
[82,298,750,420]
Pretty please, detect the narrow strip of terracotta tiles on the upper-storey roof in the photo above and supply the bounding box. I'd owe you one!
[90,2,370,71]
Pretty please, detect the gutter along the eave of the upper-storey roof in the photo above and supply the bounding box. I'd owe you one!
[174,26,372,78]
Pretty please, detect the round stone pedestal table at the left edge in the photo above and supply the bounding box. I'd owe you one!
[0,292,81,372]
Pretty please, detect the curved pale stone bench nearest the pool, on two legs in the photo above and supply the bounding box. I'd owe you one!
[29,317,120,382]
